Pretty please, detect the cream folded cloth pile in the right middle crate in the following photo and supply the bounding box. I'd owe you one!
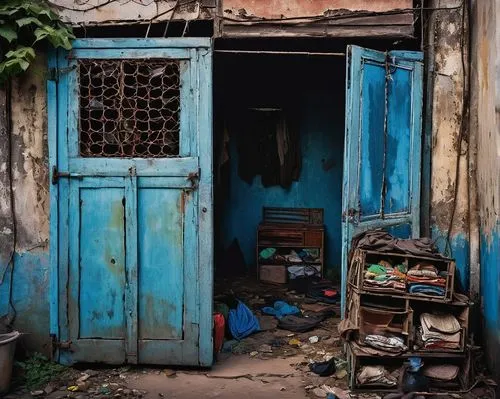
[417,313,461,350]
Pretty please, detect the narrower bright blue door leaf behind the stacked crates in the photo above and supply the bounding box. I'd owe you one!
[342,46,423,314]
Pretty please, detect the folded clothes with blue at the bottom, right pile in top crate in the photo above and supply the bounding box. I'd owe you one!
[406,263,446,296]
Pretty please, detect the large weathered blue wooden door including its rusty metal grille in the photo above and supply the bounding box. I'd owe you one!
[51,39,213,366]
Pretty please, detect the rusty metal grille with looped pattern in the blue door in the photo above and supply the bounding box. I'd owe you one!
[78,59,180,158]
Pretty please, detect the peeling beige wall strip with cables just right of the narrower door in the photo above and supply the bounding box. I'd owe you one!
[427,0,469,289]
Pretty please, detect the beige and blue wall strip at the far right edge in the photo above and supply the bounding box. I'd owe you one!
[470,0,500,379]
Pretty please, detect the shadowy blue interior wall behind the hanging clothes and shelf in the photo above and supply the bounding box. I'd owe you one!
[219,57,345,268]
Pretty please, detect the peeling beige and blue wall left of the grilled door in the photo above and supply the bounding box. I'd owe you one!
[0,56,49,351]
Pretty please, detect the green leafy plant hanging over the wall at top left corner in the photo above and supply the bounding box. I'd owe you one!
[0,0,75,83]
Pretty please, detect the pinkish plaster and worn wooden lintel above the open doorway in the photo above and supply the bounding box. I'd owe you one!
[217,0,414,38]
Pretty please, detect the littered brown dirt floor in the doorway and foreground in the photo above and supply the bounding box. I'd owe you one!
[5,278,494,399]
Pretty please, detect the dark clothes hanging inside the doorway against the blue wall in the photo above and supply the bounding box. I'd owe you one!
[238,108,302,188]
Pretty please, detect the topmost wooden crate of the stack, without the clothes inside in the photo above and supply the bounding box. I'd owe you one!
[347,249,455,302]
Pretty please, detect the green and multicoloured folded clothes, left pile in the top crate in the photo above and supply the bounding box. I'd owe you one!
[363,260,406,291]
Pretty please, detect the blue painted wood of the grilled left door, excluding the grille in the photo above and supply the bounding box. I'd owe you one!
[48,38,213,366]
